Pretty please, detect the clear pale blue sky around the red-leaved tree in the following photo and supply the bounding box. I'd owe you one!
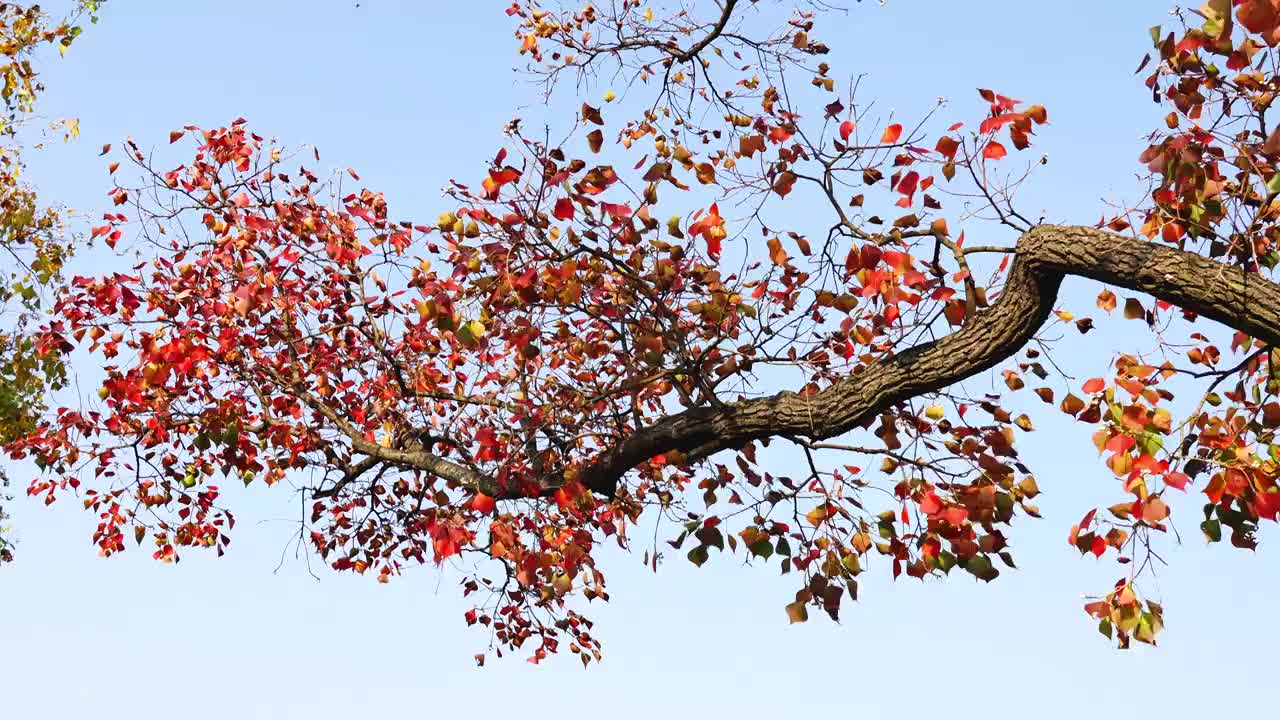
[0,0,1280,720]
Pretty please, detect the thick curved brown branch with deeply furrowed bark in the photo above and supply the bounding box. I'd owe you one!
[580,225,1280,496]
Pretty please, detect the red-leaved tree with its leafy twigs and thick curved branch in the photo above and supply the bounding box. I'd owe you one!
[5,0,1280,664]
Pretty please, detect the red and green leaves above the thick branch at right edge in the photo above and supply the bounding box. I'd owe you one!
[1136,0,1280,269]
